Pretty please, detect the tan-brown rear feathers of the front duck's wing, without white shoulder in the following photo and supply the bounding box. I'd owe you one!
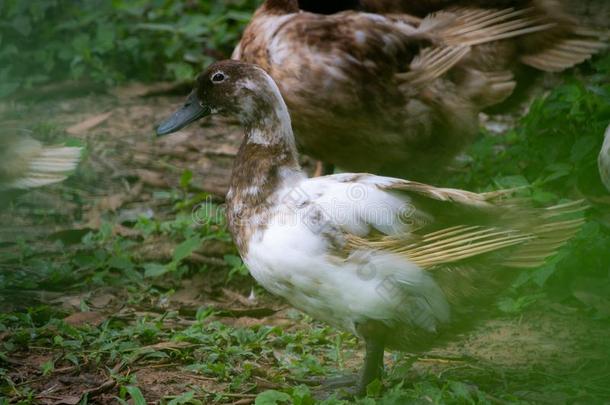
[349,182,586,271]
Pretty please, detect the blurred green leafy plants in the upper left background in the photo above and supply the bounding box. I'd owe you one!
[0,0,257,97]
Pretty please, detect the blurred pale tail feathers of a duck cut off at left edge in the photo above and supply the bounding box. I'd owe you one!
[0,128,82,191]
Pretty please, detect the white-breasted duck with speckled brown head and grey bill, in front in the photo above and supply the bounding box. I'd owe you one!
[156,60,586,394]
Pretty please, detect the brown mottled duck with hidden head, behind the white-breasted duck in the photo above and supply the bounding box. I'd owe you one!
[232,0,606,181]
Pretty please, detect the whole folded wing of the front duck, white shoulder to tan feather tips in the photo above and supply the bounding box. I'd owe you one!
[300,174,586,271]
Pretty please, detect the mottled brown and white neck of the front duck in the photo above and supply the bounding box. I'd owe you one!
[227,81,305,250]
